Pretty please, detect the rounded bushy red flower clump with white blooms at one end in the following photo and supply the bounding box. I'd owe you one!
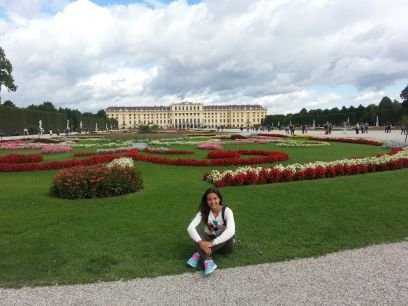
[51,159,143,199]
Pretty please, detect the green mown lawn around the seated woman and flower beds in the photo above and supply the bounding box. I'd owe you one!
[0,143,408,287]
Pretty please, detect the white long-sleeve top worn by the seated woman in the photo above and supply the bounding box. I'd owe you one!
[187,207,235,245]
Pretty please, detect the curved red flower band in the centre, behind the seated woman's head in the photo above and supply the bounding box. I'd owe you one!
[126,150,289,166]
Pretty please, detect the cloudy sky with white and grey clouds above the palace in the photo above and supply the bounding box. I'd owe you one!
[0,0,408,114]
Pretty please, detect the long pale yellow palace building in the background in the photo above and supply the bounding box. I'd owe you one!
[106,102,266,129]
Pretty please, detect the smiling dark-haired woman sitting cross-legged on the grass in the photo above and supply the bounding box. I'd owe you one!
[187,188,235,275]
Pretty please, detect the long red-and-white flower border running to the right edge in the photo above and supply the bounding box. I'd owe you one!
[204,148,408,187]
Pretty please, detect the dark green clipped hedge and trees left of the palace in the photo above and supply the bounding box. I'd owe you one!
[0,101,118,135]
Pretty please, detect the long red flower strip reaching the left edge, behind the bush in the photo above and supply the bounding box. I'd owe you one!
[0,154,121,172]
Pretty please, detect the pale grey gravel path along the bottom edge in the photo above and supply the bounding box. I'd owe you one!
[0,242,408,305]
